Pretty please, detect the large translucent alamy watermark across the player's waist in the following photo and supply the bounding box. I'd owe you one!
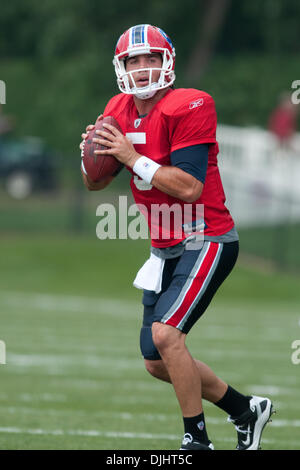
[96,196,205,249]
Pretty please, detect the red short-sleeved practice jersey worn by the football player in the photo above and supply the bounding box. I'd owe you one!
[104,88,234,248]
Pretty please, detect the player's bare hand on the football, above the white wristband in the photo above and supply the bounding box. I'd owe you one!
[93,123,141,168]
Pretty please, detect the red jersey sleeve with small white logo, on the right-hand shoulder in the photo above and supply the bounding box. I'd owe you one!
[166,92,217,152]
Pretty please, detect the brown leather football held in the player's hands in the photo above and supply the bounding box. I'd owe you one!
[81,116,123,182]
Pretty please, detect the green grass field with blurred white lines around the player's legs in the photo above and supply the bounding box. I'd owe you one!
[0,235,300,450]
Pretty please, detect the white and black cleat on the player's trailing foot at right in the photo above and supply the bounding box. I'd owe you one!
[228,396,275,450]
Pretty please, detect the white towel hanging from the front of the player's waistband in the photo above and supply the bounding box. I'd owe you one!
[133,253,165,294]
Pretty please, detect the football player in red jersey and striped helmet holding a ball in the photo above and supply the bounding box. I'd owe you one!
[81,24,273,450]
